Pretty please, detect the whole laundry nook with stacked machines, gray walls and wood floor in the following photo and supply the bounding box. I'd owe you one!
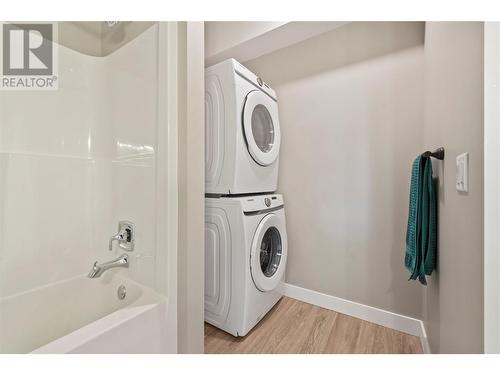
[205,22,484,353]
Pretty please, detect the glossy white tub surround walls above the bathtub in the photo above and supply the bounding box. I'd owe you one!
[0,24,162,297]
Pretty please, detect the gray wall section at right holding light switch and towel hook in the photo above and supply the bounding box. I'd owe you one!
[424,22,484,353]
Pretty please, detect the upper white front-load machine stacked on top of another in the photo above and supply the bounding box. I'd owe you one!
[205,59,281,195]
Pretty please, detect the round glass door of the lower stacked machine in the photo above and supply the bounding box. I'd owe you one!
[250,214,287,292]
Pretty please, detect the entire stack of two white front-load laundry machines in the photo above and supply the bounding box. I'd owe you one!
[205,59,287,336]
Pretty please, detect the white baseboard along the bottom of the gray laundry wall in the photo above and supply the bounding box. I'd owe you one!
[281,283,430,353]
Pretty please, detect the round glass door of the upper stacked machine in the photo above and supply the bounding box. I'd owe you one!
[243,90,281,166]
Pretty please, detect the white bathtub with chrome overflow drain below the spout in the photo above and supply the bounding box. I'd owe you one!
[0,272,167,353]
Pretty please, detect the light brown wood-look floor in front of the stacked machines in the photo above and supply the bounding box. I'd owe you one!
[205,297,422,354]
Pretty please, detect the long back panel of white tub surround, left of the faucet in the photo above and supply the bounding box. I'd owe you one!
[0,41,106,297]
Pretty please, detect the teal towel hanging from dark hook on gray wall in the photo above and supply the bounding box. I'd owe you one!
[405,155,437,285]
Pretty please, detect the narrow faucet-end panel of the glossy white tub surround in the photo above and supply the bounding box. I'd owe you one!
[106,24,164,288]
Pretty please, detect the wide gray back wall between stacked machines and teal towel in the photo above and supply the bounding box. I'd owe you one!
[245,22,424,318]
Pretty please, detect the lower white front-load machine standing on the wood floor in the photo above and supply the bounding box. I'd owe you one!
[205,194,287,336]
